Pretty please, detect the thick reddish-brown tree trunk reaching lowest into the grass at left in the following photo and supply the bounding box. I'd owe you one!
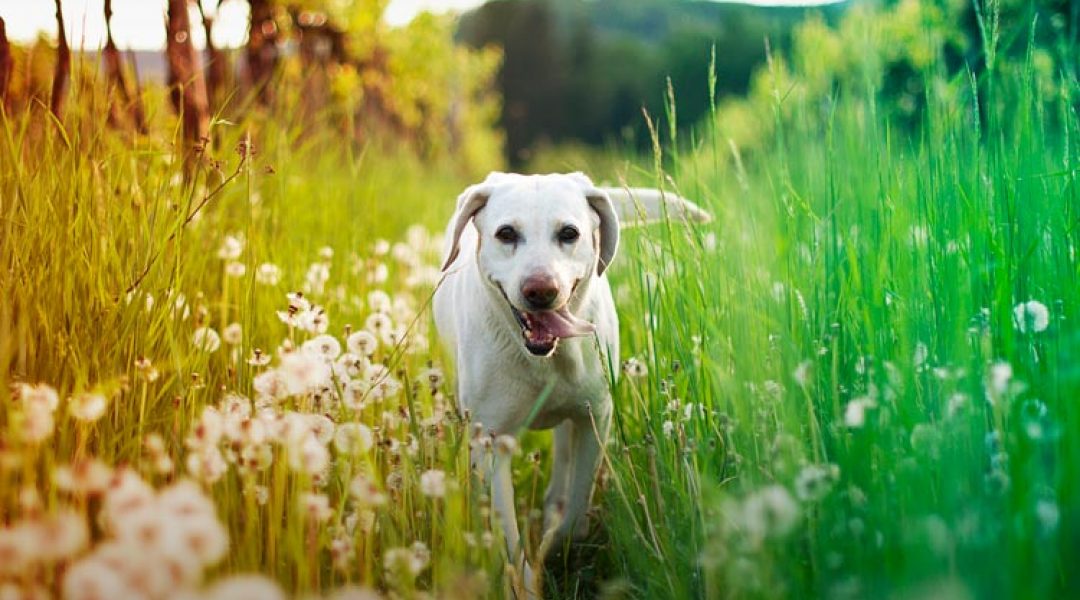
[165,0,210,157]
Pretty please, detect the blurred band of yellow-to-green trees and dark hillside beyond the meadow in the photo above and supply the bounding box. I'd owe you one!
[0,0,1080,172]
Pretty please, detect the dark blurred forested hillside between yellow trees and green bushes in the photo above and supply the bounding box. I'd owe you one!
[458,0,846,163]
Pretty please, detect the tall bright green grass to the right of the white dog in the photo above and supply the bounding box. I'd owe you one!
[604,21,1080,598]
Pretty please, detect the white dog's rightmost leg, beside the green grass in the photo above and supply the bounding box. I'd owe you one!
[559,396,611,538]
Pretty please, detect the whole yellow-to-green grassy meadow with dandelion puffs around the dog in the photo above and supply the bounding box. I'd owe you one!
[0,4,1080,599]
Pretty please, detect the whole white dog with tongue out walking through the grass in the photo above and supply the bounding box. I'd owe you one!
[434,173,708,596]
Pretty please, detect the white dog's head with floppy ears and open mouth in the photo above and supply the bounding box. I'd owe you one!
[443,173,619,356]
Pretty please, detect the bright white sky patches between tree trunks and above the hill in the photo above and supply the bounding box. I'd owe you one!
[0,0,835,50]
